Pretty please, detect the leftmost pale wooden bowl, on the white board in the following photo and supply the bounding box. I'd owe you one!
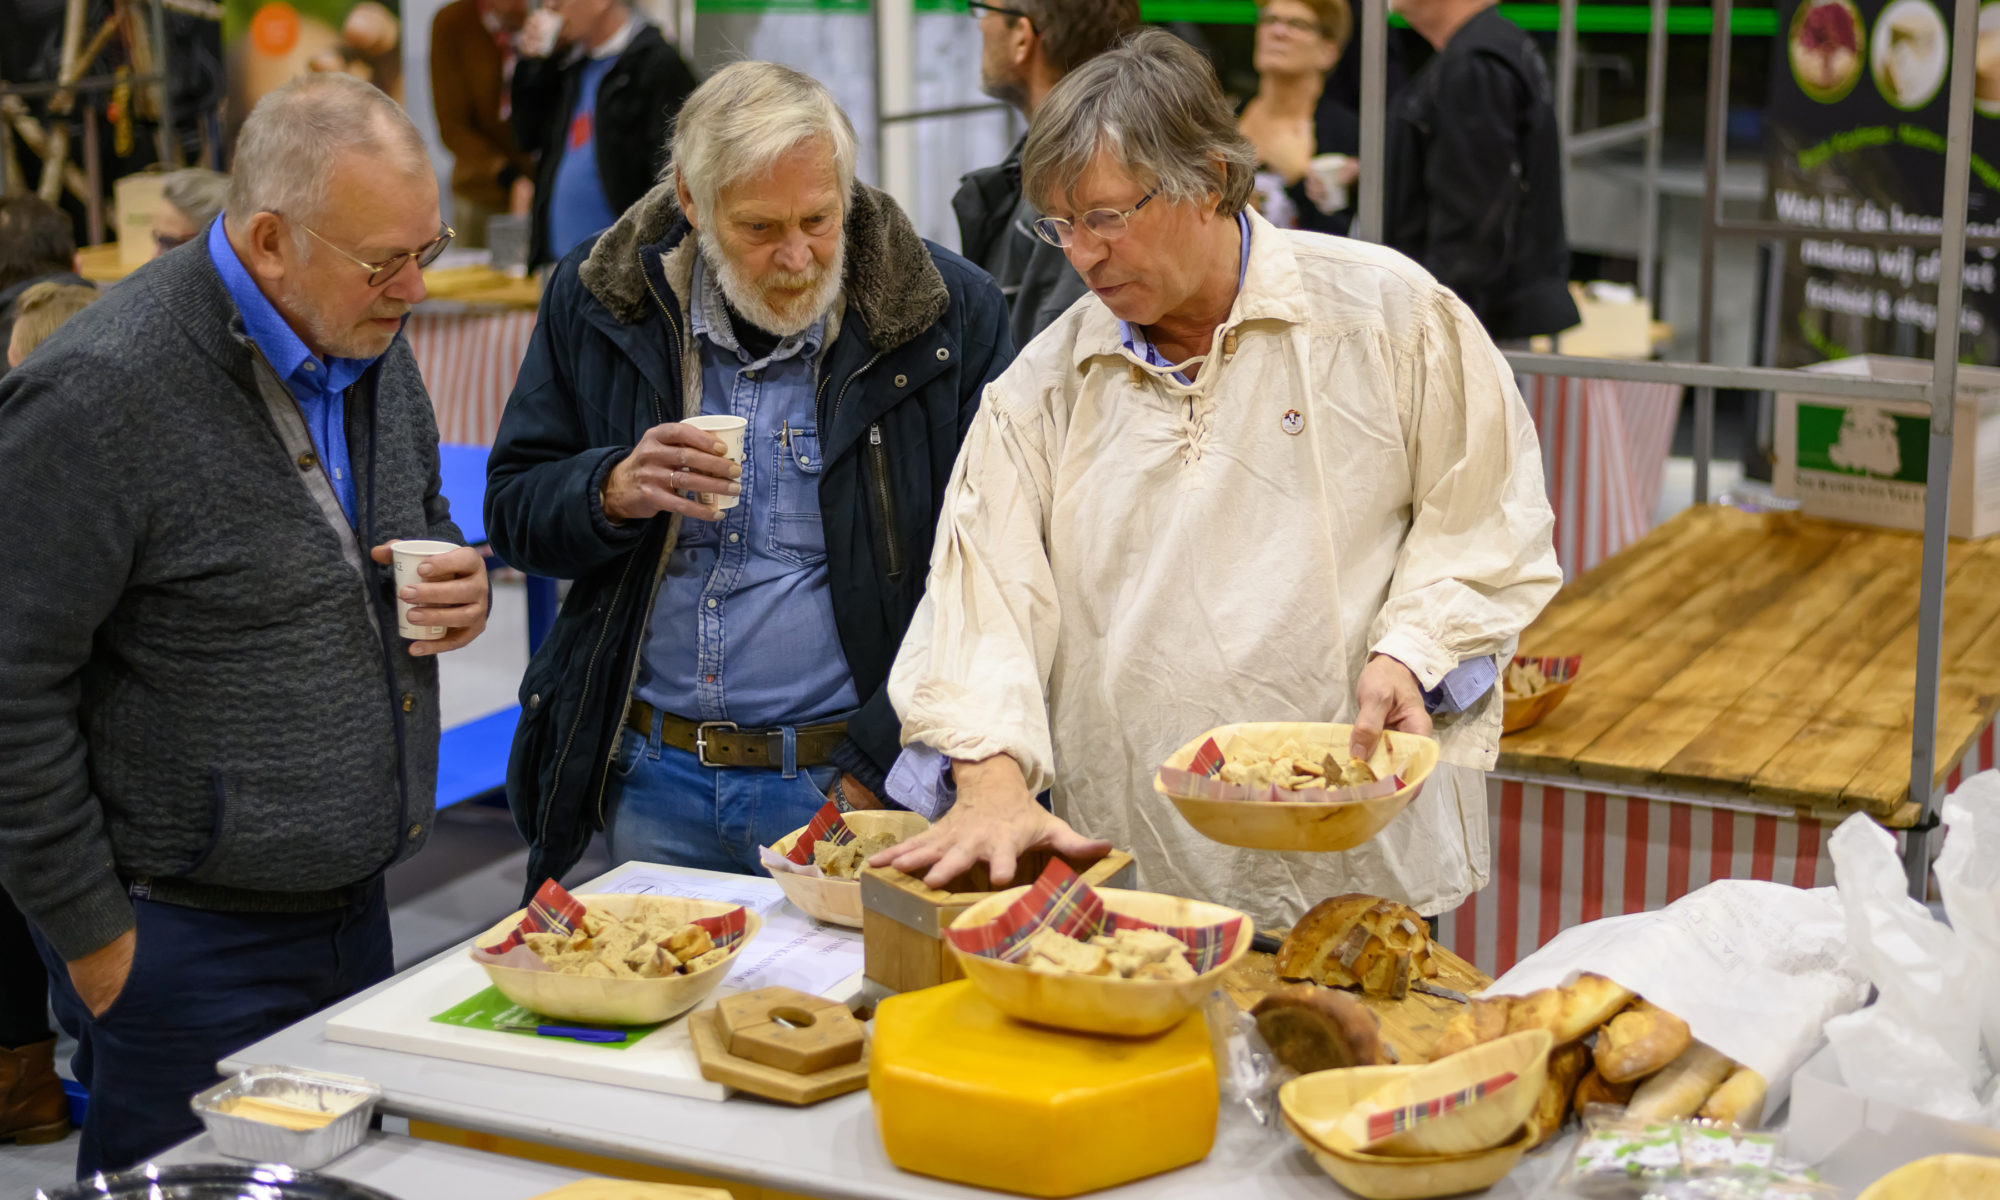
[474,896,764,1026]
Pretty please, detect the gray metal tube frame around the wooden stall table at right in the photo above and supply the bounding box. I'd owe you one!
[1356,0,1988,900]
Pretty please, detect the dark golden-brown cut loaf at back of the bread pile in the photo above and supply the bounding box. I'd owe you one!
[1276,892,1438,1000]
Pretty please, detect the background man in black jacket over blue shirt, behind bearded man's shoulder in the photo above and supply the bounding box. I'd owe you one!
[512,0,694,266]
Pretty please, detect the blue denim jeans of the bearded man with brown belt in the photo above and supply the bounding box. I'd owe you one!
[604,712,840,874]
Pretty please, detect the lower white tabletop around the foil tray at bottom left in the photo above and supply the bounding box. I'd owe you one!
[154,1134,598,1200]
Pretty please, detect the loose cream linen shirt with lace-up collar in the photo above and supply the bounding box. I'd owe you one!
[890,212,1562,926]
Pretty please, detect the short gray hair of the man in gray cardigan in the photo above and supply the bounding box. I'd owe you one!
[228,72,430,238]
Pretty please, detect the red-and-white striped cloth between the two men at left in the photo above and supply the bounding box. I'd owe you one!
[404,310,534,446]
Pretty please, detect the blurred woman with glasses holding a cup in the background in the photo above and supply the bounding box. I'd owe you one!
[1236,0,1362,234]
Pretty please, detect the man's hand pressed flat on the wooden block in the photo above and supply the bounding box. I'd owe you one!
[868,754,1112,888]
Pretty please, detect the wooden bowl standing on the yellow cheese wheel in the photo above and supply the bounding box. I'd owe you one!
[948,888,1254,1038]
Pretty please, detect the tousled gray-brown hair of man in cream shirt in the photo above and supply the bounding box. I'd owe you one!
[1020,30,1256,216]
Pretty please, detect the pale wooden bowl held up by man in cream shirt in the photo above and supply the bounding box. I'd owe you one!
[1152,722,1438,852]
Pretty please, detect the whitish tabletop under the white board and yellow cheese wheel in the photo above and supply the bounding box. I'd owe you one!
[220,868,1570,1200]
